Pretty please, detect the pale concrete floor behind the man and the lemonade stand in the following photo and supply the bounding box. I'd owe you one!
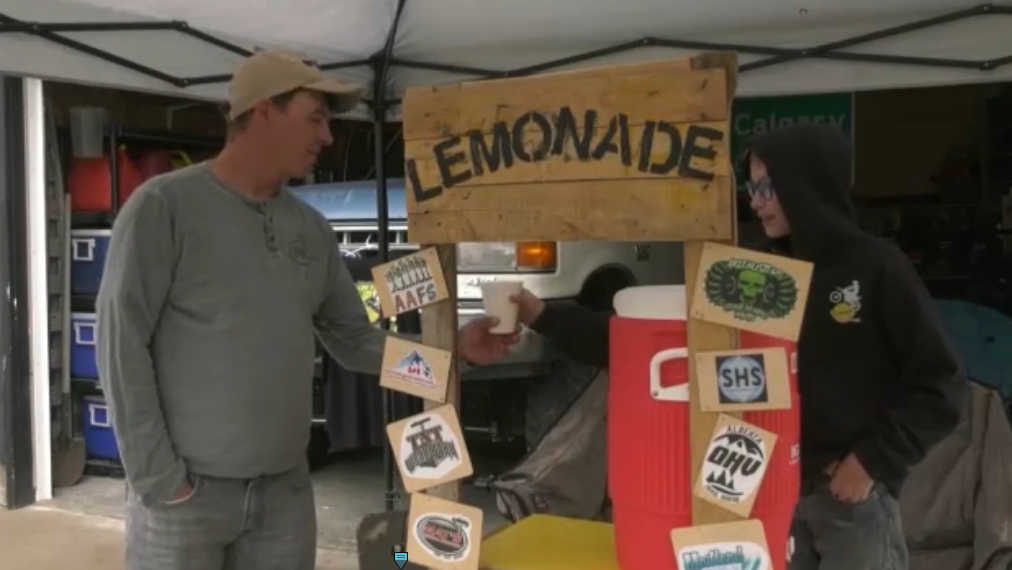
[17,450,515,570]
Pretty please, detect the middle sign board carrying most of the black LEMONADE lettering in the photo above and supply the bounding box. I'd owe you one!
[404,120,731,189]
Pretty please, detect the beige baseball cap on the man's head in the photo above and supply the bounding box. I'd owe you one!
[229,50,364,119]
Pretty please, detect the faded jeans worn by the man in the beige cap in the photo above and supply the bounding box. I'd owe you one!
[127,467,317,570]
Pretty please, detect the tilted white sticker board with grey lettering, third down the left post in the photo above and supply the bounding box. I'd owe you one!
[387,404,474,493]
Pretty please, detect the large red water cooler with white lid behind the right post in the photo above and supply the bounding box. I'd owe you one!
[608,286,799,570]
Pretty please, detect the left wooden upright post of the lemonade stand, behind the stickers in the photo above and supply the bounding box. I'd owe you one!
[421,245,460,501]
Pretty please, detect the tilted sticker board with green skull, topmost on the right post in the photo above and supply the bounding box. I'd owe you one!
[689,242,813,341]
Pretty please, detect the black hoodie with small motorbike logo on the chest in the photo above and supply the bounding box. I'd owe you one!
[532,126,965,495]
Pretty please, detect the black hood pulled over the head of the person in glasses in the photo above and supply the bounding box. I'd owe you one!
[743,124,863,261]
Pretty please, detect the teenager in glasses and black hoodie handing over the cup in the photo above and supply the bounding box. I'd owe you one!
[515,125,965,570]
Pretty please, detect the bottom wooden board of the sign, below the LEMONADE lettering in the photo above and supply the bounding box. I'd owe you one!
[408,177,734,242]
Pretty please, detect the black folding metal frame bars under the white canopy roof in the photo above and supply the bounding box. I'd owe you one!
[0,0,1012,92]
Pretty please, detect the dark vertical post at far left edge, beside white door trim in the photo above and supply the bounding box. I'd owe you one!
[0,77,35,508]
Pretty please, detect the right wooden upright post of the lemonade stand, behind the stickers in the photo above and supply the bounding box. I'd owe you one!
[685,241,742,525]
